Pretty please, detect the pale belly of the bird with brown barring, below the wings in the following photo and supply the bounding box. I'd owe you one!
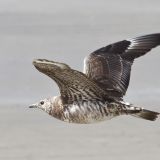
[63,103,115,124]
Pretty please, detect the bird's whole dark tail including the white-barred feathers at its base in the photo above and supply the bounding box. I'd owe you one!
[130,107,160,121]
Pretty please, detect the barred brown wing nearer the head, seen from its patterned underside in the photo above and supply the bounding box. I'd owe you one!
[33,59,109,105]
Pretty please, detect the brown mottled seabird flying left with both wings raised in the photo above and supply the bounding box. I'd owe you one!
[29,33,160,124]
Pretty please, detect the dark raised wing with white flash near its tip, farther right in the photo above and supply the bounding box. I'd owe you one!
[84,33,160,97]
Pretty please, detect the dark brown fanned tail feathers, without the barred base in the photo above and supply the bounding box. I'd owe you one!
[131,109,160,121]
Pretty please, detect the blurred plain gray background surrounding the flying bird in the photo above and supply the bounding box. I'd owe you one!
[0,0,160,160]
